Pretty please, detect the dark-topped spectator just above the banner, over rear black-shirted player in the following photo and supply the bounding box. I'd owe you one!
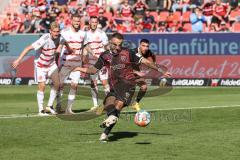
[143,10,155,32]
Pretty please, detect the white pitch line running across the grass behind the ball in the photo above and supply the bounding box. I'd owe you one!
[0,104,240,119]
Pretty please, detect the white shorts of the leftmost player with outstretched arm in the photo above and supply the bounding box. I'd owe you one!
[34,64,58,83]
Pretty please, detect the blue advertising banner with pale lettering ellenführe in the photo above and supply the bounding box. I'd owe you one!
[124,33,240,56]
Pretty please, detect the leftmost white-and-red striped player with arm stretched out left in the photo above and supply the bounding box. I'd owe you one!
[12,22,65,115]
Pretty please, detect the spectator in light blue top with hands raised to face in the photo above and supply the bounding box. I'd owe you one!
[190,7,206,32]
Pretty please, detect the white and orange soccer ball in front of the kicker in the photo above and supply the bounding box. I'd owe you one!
[134,110,151,127]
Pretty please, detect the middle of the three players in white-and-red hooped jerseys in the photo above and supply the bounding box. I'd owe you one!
[57,14,86,114]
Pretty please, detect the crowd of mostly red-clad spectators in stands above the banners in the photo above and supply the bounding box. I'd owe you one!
[0,0,240,33]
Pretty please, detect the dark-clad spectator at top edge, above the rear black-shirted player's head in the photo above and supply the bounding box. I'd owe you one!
[133,0,149,19]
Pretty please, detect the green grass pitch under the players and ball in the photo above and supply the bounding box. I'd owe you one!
[0,86,240,160]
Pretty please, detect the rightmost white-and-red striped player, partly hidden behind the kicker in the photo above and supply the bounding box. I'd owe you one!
[84,16,110,110]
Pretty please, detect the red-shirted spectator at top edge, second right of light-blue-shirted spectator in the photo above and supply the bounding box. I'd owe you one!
[212,0,231,25]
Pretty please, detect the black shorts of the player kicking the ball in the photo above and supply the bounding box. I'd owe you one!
[103,82,135,106]
